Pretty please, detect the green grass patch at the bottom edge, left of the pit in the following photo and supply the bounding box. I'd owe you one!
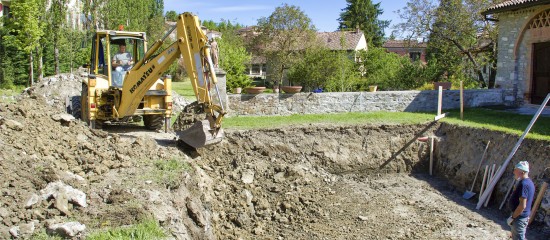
[86,220,166,240]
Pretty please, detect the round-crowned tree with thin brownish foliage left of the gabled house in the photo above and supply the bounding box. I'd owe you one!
[254,4,315,86]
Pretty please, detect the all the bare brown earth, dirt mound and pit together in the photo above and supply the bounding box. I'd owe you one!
[0,75,549,239]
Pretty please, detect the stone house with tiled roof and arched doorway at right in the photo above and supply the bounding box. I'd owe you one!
[482,0,550,105]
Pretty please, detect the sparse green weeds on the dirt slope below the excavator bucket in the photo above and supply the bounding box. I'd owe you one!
[154,159,191,190]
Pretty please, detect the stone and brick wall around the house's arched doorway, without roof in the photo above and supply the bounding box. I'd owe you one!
[496,5,550,105]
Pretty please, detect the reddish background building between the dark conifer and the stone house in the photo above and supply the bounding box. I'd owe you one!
[382,40,426,63]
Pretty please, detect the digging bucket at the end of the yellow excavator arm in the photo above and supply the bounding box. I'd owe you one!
[176,120,224,148]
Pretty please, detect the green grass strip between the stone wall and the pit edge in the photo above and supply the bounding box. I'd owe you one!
[223,109,550,141]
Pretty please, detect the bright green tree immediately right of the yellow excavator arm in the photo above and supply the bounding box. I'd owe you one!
[218,32,252,91]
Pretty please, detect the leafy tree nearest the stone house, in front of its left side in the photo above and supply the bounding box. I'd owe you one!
[396,0,496,87]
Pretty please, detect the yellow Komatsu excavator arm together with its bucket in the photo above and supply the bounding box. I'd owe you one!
[114,13,225,148]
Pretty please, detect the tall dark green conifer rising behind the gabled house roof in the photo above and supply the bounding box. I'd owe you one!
[338,0,390,47]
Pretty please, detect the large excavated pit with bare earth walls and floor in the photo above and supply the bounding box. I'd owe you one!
[198,123,550,239]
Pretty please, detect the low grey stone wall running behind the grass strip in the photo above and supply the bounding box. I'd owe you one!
[227,89,506,116]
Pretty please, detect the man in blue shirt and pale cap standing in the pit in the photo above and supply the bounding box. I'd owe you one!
[506,161,535,240]
